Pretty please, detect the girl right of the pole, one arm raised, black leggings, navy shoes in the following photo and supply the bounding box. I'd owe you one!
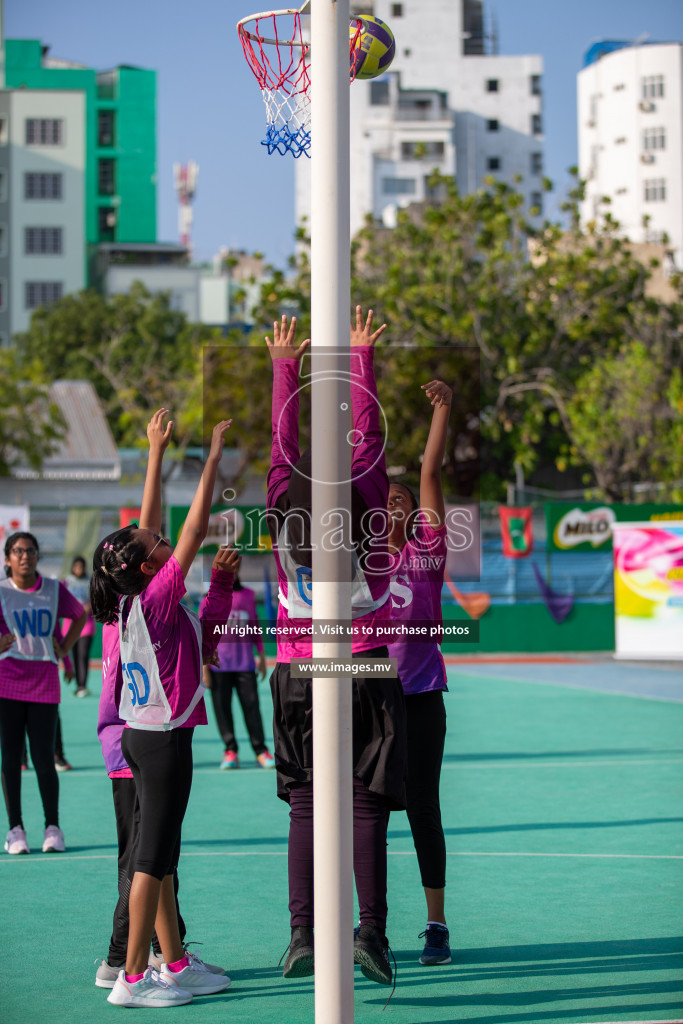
[387,381,452,966]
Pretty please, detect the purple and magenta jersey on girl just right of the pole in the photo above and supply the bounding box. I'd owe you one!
[388,515,447,693]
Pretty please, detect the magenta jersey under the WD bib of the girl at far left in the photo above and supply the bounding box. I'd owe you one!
[0,575,83,703]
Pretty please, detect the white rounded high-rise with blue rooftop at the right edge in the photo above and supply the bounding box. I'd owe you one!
[578,41,683,270]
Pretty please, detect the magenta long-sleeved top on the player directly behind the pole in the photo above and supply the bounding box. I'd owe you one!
[267,345,391,663]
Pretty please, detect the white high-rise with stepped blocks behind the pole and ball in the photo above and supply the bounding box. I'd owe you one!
[296,0,543,234]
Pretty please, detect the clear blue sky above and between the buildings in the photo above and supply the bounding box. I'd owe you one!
[4,0,683,266]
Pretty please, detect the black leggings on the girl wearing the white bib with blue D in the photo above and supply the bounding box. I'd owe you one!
[121,728,195,882]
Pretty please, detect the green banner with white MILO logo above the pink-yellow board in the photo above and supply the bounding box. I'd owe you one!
[546,502,683,551]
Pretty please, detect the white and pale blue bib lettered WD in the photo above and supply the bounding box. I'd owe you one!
[0,577,59,665]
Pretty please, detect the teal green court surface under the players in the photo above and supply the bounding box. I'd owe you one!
[0,660,683,1024]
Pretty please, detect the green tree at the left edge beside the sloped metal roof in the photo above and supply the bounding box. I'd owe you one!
[0,348,66,476]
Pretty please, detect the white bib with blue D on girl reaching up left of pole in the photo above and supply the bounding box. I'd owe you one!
[119,597,206,732]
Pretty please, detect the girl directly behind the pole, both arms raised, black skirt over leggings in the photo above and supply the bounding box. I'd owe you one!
[266,306,405,985]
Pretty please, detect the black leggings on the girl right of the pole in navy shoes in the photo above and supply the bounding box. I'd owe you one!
[405,690,445,889]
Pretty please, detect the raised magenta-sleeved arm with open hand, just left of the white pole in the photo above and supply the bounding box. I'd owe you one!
[265,315,310,508]
